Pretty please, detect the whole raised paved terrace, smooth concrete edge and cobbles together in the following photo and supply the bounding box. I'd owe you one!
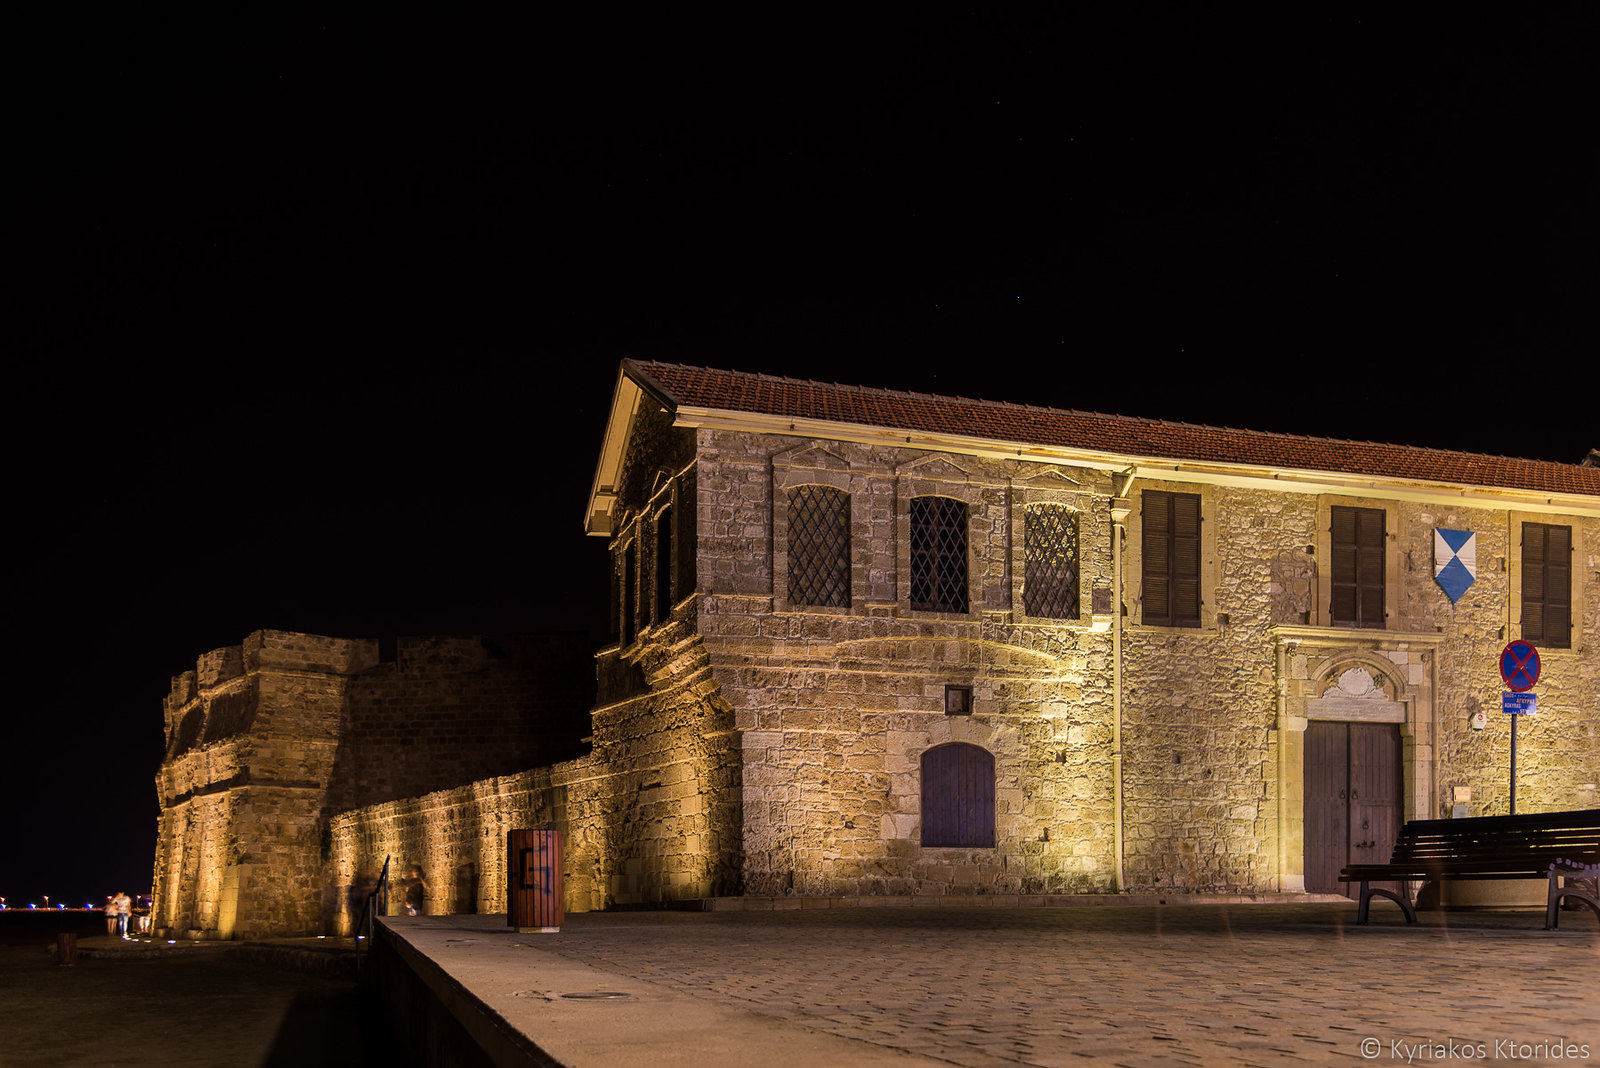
[384,903,1600,1068]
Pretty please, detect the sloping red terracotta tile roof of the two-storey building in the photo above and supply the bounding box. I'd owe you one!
[624,360,1600,496]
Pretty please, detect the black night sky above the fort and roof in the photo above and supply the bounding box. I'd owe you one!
[0,12,1600,903]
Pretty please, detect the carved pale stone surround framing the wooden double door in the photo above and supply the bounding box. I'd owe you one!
[1272,625,1445,892]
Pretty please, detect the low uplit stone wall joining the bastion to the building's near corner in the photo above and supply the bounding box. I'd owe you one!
[331,600,741,929]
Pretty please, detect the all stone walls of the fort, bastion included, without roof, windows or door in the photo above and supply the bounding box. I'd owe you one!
[157,415,1600,932]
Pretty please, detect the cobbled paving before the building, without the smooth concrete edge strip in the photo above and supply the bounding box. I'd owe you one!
[538,905,1600,1066]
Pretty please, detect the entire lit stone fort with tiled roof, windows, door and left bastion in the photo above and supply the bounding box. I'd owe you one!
[154,361,1600,938]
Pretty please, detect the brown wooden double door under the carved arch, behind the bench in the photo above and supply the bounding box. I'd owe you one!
[1304,719,1405,897]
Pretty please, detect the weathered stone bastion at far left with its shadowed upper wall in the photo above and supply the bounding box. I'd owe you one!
[152,630,592,938]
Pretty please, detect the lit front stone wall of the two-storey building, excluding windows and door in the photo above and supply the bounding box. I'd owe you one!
[678,430,1600,895]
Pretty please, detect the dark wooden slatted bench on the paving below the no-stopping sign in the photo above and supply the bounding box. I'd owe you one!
[1339,809,1600,931]
